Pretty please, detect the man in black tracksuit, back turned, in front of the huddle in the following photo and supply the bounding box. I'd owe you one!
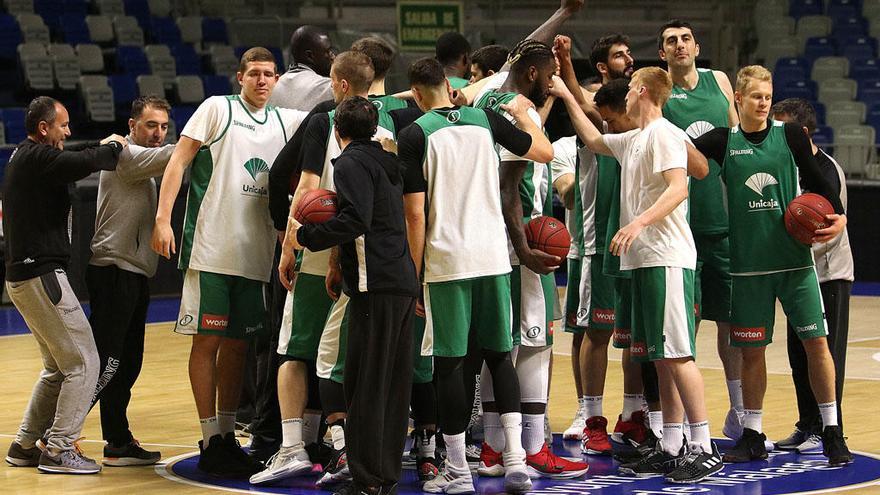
[284,97,419,494]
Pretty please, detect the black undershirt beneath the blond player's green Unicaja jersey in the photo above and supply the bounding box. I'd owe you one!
[694,122,844,214]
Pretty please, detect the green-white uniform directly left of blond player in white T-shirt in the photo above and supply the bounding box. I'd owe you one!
[551,136,617,333]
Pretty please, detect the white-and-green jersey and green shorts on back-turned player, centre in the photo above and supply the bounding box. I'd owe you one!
[408,107,512,357]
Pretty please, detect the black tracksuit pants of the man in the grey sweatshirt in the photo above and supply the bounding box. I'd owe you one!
[86,265,150,447]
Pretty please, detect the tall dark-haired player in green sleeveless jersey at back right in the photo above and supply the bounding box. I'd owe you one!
[657,19,743,440]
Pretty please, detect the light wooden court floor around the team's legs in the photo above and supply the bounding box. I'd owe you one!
[0,297,880,495]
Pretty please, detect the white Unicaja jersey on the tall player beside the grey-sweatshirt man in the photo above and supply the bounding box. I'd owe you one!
[179,95,306,282]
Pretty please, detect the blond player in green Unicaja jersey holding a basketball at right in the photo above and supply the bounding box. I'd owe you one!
[696,65,852,466]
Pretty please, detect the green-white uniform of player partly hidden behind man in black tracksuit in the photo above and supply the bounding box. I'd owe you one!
[278,101,394,364]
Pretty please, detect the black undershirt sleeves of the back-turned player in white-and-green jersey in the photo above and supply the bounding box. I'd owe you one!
[397,107,532,194]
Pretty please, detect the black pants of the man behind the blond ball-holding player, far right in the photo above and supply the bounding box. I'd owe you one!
[788,280,852,433]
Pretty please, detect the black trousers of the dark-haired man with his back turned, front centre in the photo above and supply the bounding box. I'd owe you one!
[344,292,416,487]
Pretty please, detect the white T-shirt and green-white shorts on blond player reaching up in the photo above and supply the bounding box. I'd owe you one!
[602,118,697,361]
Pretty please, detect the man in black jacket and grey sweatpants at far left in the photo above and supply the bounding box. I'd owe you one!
[3,96,126,474]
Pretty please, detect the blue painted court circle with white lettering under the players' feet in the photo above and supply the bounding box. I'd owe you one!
[164,434,880,495]
